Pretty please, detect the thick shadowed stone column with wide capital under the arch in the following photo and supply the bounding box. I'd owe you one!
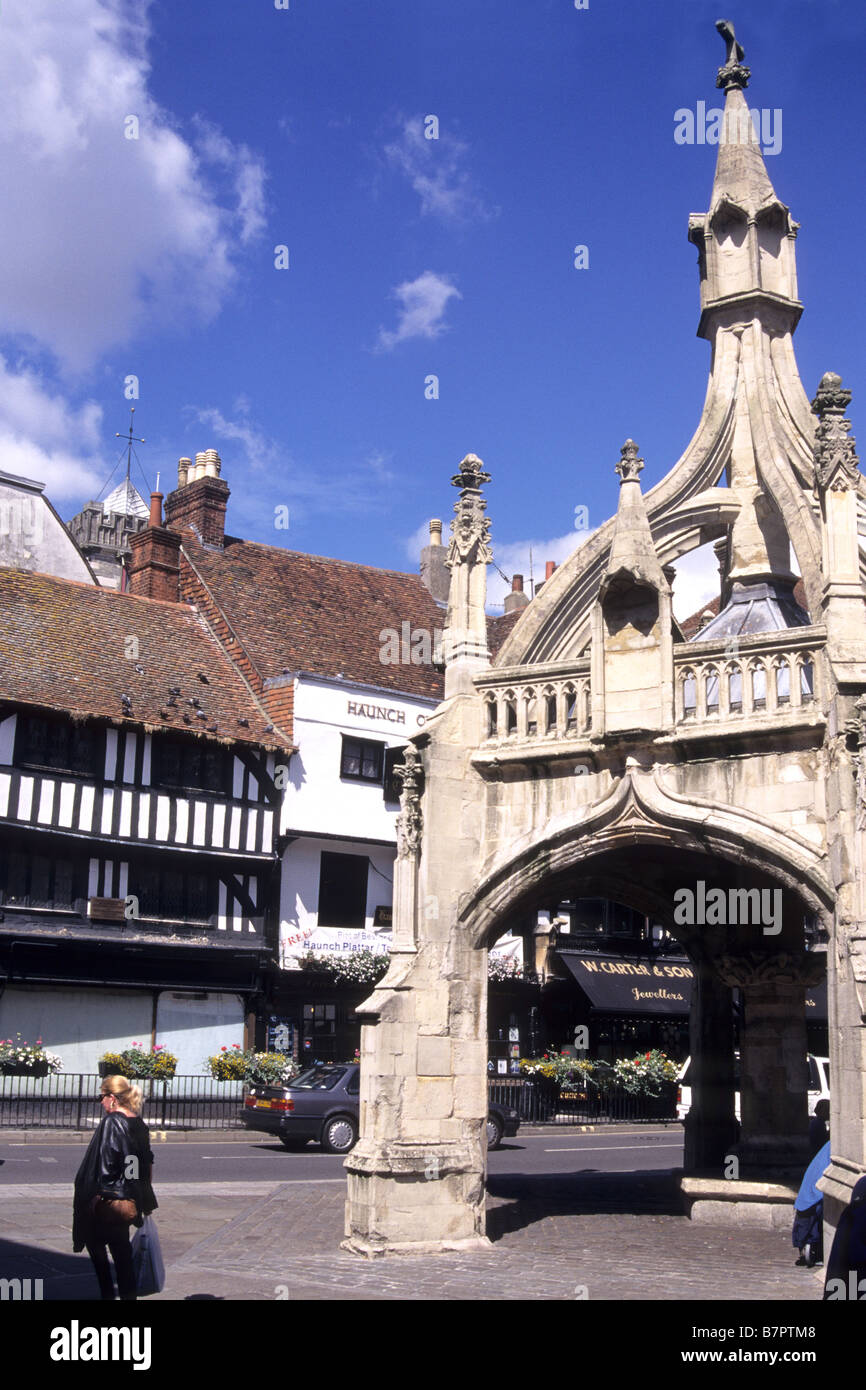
[719,951,824,1176]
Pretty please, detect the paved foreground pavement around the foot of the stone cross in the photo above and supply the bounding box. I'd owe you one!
[0,1175,823,1301]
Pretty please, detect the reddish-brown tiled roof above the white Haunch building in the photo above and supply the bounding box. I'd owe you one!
[183,530,445,699]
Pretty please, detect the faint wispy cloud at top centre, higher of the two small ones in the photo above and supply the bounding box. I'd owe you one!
[385,115,496,222]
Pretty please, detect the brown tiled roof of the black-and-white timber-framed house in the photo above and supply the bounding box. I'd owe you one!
[0,569,286,748]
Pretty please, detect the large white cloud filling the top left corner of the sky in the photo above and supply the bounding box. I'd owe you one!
[0,0,264,370]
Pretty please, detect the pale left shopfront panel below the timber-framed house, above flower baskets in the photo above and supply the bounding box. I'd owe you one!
[0,984,152,1072]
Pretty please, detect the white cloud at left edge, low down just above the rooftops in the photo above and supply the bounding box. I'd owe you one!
[0,357,110,503]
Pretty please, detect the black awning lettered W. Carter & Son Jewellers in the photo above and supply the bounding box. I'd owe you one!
[557,951,692,1015]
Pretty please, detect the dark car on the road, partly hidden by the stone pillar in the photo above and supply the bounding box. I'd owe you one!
[240,1062,520,1154]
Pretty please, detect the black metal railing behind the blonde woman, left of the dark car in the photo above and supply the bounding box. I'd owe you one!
[0,1072,245,1130]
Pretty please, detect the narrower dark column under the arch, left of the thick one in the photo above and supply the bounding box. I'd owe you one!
[684,956,737,1173]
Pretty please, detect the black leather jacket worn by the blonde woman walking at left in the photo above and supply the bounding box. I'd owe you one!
[72,1111,157,1251]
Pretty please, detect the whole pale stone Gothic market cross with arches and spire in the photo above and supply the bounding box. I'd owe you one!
[346,32,866,1254]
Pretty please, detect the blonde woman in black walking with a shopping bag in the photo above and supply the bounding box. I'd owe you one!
[72,1076,157,1300]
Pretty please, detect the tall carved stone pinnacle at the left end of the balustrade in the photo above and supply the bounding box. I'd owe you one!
[442,453,493,699]
